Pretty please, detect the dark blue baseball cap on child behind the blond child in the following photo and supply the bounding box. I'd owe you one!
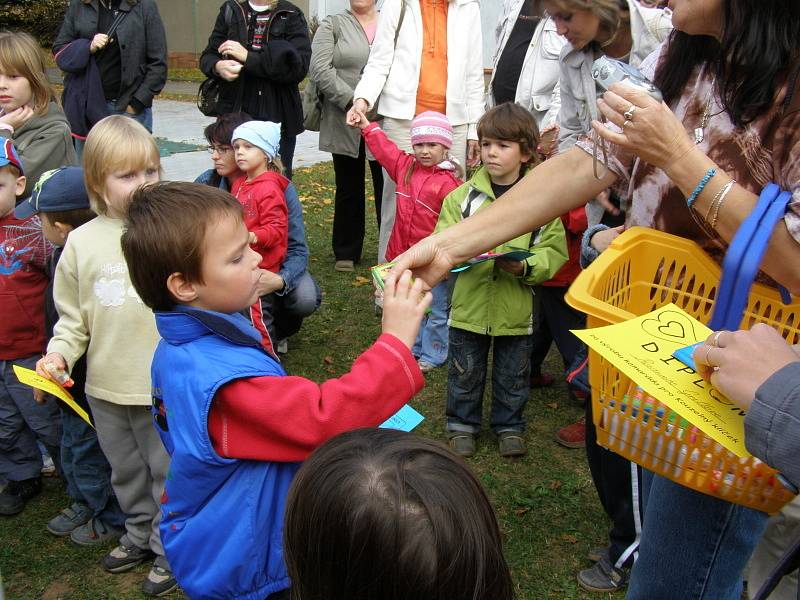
[14,166,97,229]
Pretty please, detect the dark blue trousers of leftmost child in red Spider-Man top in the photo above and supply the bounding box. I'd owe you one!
[0,355,61,481]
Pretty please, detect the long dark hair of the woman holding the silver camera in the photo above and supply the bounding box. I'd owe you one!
[655,0,800,127]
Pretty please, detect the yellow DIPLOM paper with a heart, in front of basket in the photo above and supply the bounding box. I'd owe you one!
[573,304,750,457]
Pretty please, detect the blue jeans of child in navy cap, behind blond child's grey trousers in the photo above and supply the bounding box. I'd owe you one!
[61,410,125,529]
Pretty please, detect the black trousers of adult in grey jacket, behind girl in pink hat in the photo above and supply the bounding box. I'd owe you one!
[332,140,383,262]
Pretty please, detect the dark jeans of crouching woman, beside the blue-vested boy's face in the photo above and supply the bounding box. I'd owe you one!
[261,271,322,343]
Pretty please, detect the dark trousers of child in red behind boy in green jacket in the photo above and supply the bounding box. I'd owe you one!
[531,285,586,375]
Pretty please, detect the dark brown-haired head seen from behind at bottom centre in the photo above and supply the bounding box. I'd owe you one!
[284,429,514,600]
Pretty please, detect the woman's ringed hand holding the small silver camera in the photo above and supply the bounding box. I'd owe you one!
[592,83,695,170]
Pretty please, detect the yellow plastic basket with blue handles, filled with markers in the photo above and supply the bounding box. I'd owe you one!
[567,227,800,512]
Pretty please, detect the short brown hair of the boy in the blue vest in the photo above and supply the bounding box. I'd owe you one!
[122,181,243,310]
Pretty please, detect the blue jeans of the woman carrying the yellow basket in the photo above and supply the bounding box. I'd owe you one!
[626,470,767,600]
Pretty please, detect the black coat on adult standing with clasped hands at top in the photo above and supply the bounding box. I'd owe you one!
[200,0,311,135]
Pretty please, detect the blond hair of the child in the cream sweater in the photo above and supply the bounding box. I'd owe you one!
[83,115,161,215]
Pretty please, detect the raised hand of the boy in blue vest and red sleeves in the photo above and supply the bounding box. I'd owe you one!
[381,271,433,350]
